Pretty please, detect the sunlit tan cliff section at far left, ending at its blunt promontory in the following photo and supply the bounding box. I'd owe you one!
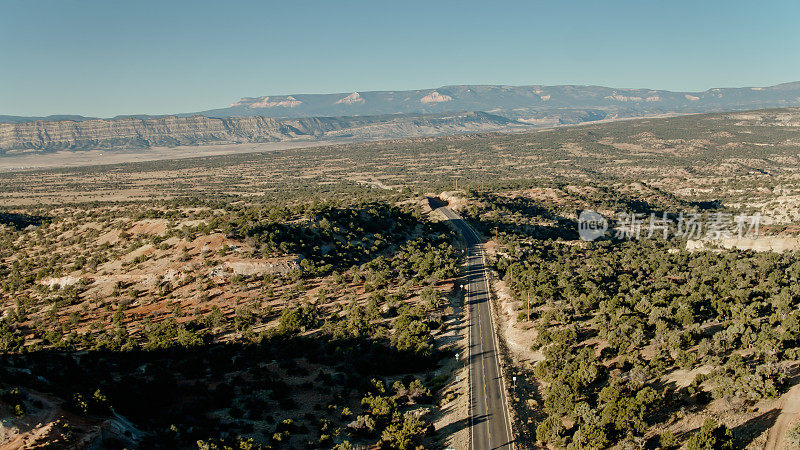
[0,116,309,153]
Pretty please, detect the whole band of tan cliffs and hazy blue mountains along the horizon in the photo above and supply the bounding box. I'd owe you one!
[0,82,800,155]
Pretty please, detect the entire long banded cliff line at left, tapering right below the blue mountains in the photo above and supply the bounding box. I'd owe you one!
[0,113,527,155]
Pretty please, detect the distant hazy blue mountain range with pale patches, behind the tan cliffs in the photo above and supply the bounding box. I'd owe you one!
[192,82,800,123]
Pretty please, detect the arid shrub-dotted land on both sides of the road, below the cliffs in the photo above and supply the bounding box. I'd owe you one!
[0,108,800,449]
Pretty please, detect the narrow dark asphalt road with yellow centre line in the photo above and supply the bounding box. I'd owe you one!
[439,207,513,450]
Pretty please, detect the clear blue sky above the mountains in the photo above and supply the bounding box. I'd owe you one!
[0,0,800,117]
